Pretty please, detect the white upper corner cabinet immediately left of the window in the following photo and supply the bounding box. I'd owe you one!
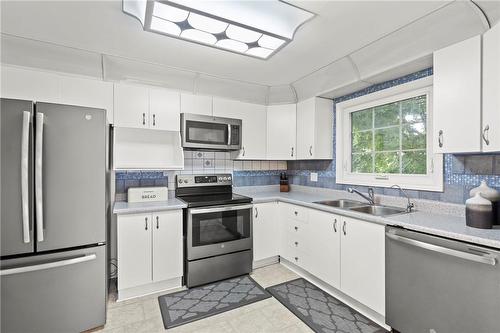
[297,97,333,160]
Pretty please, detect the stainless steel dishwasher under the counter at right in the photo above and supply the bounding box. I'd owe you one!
[385,227,500,333]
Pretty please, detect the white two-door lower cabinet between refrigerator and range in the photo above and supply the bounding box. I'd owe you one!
[117,210,183,299]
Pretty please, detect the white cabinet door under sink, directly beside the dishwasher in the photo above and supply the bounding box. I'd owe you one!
[340,218,385,315]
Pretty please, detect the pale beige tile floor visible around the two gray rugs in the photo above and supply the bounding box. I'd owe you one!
[98,264,312,333]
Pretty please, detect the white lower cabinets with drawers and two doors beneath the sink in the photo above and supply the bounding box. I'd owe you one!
[276,202,385,315]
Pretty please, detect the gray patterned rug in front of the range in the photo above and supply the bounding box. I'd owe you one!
[158,275,271,328]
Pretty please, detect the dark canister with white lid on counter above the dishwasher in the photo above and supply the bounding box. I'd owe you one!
[465,192,493,229]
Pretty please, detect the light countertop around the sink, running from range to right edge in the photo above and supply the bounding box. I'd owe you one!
[233,187,500,249]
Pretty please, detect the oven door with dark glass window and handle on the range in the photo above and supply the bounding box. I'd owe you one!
[187,204,253,260]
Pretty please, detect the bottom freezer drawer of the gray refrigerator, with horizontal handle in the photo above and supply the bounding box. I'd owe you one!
[1,245,106,333]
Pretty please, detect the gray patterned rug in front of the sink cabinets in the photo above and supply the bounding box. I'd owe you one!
[266,278,387,333]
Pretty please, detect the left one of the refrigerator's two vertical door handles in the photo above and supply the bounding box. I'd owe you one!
[21,111,31,243]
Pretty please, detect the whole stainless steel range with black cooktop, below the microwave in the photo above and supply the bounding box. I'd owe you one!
[175,174,253,287]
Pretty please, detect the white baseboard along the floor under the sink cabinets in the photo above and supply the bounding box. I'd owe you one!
[280,257,391,331]
